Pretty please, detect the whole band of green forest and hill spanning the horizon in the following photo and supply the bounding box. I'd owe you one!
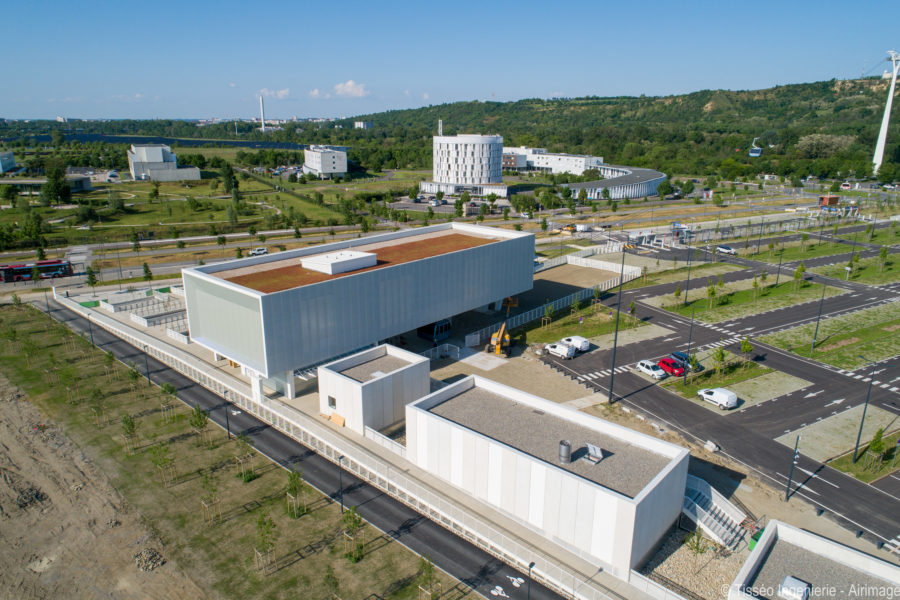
[0,78,900,181]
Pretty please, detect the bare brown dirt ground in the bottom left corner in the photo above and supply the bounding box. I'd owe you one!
[0,376,205,600]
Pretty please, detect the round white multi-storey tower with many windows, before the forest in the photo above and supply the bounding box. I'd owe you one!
[421,134,506,198]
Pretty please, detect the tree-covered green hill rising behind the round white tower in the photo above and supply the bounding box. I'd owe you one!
[348,79,900,177]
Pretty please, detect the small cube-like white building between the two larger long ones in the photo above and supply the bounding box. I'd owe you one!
[318,344,431,435]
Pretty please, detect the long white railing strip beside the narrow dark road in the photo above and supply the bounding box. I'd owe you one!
[54,289,625,600]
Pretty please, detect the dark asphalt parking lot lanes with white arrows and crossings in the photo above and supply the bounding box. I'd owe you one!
[543,234,900,541]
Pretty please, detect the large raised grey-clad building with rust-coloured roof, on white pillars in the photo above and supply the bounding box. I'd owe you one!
[183,223,534,406]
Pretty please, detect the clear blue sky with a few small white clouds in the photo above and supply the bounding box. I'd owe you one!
[0,0,900,118]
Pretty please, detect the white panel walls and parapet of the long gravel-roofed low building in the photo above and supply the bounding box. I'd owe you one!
[406,376,688,579]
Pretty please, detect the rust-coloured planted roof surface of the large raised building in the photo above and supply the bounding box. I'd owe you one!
[223,233,497,294]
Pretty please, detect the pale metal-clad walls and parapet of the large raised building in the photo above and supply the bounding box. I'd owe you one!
[184,224,534,377]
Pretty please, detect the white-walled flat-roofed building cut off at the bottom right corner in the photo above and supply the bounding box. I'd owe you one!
[728,521,900,600]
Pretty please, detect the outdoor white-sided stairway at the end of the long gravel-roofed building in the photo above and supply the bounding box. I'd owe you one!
[681,475,746,550]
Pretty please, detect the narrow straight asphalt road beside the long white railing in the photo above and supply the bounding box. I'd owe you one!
[45,301,562,600]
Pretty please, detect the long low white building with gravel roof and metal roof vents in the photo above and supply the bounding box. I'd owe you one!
[406,375,689,580]
